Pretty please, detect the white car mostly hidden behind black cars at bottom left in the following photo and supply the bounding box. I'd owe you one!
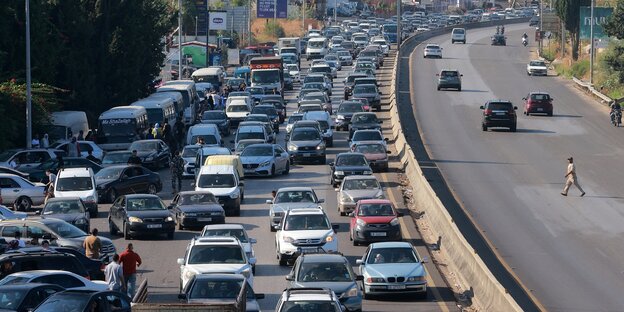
[0,270,108,291]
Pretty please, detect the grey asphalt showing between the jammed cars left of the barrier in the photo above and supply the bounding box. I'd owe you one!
[86,51,457,311]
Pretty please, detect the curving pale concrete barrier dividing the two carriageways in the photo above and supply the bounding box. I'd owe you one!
[390,19,528,311]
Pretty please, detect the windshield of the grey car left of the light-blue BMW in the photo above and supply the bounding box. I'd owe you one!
[297,262,353,283]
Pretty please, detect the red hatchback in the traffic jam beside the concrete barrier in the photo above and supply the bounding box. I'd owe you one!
[349,199,402,246]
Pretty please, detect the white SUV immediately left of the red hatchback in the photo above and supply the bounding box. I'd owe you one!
[275,208,338,266]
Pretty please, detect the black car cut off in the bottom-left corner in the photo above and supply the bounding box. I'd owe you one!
[0,283,65,312]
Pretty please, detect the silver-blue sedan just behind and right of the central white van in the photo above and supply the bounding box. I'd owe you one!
[240,143,290,177]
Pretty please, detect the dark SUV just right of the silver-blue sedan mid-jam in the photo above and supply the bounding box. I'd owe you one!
[287,127,327,164]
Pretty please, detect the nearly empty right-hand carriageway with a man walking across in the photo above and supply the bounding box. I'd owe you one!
[410,25,624,311]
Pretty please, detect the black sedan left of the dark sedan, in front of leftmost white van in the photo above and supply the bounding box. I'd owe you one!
[108,194,176,239]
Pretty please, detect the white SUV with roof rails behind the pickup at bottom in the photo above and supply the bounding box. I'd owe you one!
[178,237,254,291]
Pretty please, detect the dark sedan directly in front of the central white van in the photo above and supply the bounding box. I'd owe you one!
[168,191,225,230]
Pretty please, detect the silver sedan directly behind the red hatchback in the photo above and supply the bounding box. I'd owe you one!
[335,175,385,216]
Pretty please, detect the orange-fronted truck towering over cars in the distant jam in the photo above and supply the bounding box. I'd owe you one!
[249,56,284,94]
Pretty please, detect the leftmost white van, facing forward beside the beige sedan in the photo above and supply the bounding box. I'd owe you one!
[54,168,98,218]
